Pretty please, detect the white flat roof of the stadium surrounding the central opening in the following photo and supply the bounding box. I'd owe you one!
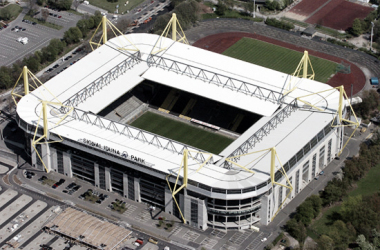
[17,34,339,191]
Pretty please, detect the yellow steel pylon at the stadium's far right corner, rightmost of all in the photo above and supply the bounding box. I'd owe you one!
[297,85,360,156]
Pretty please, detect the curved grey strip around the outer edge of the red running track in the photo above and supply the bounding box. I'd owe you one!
[186,18,380,85]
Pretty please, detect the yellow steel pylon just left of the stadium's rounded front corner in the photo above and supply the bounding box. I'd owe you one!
[166,149,212,223]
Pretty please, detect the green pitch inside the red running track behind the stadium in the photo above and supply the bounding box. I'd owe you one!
[223,37,337,83]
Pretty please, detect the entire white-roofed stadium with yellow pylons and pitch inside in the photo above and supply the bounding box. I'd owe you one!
[17,16,346,230]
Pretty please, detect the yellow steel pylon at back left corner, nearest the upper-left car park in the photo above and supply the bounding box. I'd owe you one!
[89,16,139,51]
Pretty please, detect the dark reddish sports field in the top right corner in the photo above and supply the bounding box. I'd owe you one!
[306,0,374,30]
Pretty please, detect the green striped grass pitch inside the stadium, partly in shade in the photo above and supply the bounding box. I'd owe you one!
[131,112,233,154]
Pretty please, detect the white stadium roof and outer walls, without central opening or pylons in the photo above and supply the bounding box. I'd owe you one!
[17,34,343,230]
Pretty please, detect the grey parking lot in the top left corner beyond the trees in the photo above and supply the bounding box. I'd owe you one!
[0,10,82,66]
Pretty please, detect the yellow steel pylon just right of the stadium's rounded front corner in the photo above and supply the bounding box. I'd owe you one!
[226,147,293,221]
